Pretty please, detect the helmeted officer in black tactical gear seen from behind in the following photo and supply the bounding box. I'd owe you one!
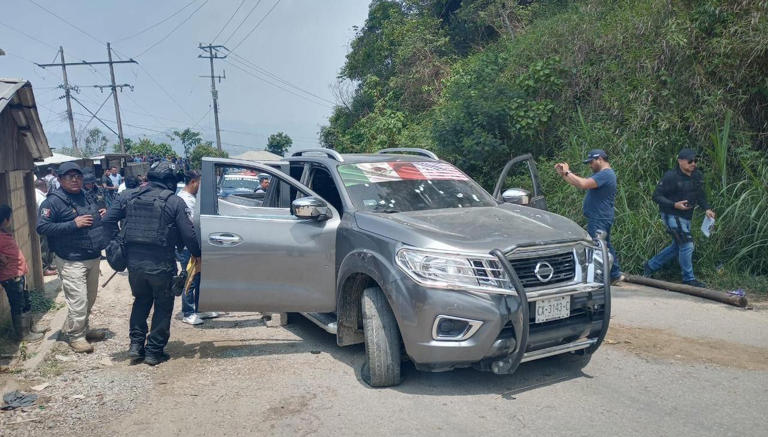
[104,162,200,366]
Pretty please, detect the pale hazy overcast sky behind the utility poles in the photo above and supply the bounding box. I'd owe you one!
[0,0,369,155]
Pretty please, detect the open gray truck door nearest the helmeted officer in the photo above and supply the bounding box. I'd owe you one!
[198,158,341,312]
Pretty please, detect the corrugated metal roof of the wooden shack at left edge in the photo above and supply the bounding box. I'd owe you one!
[0,78,51,161]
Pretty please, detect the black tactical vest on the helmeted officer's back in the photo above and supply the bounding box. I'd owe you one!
[125,187,174,250]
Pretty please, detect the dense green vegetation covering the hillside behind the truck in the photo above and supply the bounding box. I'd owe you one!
[321,0,768,290]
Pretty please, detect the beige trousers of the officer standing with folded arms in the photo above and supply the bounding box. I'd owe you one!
[54,256,100,341]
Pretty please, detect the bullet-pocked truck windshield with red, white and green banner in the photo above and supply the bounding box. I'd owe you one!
[339,161,496,213]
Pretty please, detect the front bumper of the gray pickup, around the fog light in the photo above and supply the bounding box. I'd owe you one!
[390,276,606,373]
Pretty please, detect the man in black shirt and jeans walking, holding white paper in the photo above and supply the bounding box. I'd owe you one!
[643,149,715,287]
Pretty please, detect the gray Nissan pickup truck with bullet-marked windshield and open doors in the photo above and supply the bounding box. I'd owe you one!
[195,149,611,387]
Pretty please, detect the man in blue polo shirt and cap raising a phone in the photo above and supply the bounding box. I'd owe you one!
[555,149,622,283]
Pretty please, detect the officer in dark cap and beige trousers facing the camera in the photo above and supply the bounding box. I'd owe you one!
[37,162,109,352]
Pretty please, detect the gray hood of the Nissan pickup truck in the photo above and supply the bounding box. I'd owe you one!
[355,204,590,253]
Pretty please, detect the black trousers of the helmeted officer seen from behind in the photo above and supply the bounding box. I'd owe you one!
[128,270,175,355]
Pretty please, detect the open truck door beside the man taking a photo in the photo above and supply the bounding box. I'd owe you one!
[493,153,547,210]
